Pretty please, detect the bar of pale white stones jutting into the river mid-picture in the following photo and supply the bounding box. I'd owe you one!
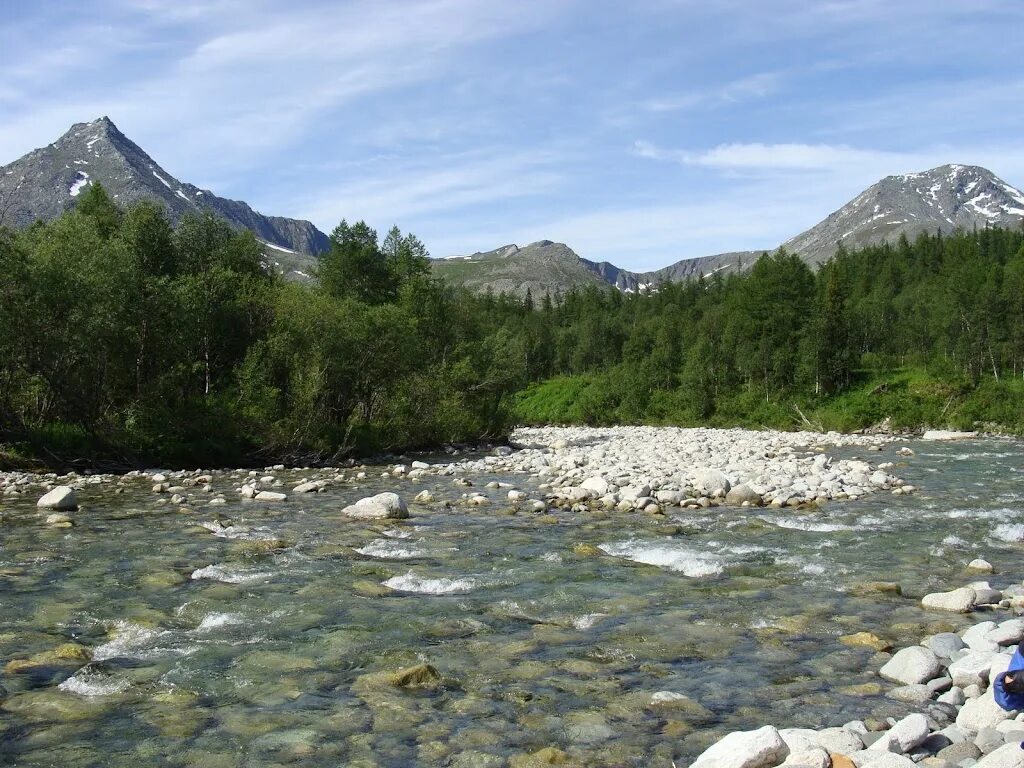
[430,427,914,512]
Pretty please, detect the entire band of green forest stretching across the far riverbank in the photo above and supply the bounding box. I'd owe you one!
[0,184,1024,466]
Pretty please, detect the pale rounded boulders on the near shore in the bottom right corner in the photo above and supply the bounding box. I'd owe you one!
[690,560,1024,768]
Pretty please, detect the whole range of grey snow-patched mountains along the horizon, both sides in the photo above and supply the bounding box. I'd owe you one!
[0,117,1024,297]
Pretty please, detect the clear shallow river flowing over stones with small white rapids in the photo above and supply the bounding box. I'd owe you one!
[0,440,1024,766]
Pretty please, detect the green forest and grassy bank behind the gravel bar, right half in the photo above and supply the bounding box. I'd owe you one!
[499,228,1024,429]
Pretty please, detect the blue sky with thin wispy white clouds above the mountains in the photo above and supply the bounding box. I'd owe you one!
[0,0,1024,269]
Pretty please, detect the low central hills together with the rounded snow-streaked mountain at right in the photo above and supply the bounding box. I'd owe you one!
[434,165,1024,296]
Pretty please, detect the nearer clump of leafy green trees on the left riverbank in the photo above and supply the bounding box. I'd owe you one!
[0,184,524,466]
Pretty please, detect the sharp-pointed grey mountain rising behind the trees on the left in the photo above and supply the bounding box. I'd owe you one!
[0,117,330,278]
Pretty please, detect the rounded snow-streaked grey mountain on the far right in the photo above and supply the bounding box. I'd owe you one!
[783,165,1024,266]
